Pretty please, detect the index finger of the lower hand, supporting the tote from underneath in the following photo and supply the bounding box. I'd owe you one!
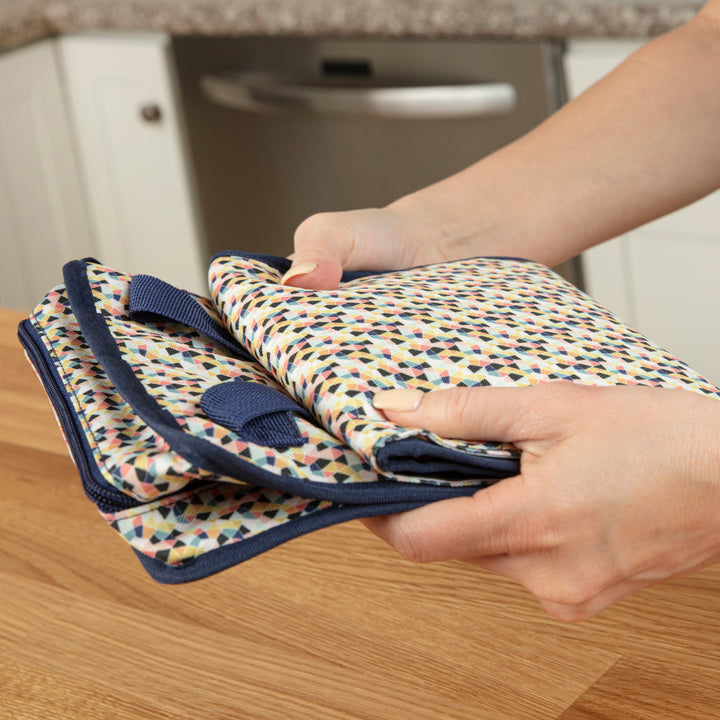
[364,476,544,563]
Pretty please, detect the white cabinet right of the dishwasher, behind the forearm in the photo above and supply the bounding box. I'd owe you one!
[565,40,720,384]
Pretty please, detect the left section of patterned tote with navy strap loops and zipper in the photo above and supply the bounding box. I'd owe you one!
[19,261,490,583]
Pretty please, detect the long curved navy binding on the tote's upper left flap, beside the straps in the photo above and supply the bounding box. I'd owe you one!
[63,261,490,505]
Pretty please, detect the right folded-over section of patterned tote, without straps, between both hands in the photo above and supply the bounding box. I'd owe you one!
[209,253,720,477]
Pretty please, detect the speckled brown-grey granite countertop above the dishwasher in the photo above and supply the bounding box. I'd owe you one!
[0,0,703,49]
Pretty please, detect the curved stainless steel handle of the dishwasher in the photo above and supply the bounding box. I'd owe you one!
[200,73,517,119]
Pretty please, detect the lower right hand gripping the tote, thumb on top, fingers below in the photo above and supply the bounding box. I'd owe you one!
[364,382,720,621]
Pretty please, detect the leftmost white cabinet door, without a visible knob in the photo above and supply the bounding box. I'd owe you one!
[0,40,94,311]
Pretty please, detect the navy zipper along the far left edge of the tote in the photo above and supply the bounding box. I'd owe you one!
[18,320,142,512]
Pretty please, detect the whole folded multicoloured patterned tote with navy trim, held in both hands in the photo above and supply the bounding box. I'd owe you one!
[19,253,720,583]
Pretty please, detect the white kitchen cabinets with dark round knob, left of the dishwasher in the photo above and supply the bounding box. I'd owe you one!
[0,34,207,310]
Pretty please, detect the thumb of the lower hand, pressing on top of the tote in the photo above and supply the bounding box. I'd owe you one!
[373,382,580,447]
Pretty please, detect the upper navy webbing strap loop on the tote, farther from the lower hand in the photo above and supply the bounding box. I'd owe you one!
[128,275,255,362]
